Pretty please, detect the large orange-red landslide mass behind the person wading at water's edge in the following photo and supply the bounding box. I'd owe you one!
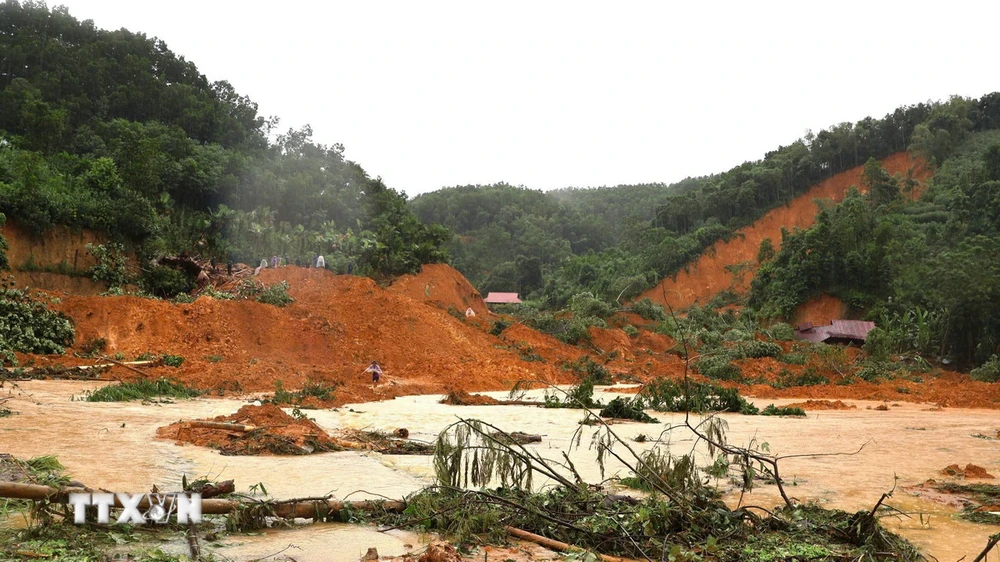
[48,266,572,403]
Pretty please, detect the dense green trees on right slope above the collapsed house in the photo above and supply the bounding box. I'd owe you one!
[750,130,1000,364]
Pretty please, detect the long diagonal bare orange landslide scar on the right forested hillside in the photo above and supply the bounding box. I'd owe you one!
[639,152,930,308]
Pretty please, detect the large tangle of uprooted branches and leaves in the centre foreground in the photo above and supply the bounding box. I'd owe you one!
[371,418,920,561]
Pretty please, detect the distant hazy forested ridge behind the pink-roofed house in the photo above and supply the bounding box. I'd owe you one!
[411,93,1000,308]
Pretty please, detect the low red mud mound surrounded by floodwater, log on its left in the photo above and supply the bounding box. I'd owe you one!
[156,404,340,455]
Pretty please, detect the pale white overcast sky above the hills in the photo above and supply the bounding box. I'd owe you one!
[50,0,1000,196]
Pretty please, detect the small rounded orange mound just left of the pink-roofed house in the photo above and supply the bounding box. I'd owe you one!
[389,263,490,317]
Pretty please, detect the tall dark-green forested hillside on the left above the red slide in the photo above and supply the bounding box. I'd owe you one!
[0,0,449,288]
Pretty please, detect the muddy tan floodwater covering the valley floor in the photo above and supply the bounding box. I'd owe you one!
[0,381,1000,561]
